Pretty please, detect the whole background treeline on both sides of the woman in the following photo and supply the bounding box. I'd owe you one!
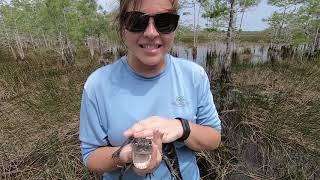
[0,0,320,65]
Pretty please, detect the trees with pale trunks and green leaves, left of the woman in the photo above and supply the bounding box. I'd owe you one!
[0,0,117,65]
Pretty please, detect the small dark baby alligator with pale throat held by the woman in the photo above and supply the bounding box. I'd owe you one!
[112,137,182,180]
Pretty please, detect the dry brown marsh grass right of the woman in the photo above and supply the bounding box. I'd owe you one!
[200,61,320,179]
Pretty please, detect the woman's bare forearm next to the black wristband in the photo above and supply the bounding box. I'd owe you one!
[184,122,221,151]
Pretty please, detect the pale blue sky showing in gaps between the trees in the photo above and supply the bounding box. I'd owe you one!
[97,0,277,31]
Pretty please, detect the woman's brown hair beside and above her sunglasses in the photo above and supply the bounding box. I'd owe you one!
[115,0,179,40]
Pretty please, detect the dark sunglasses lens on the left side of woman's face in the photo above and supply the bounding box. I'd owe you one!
[125,11,149,32]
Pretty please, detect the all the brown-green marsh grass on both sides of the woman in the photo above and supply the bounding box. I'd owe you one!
[0,47,320,179]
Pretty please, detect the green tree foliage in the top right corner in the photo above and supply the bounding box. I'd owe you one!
[267,0,320,49]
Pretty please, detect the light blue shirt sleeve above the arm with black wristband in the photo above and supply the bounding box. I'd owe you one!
[197,69,221,133]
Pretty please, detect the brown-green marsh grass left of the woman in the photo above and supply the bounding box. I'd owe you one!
[0,49,98,179]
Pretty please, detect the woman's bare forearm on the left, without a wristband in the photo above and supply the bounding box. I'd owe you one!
[87,147,123,173]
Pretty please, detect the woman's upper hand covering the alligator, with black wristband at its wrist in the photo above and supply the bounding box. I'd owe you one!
[124,116,183,143]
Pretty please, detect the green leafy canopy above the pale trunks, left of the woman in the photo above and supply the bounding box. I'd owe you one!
[0,0,115,49]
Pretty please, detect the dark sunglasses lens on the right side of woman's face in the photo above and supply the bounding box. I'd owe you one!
[154,13,179,33]
